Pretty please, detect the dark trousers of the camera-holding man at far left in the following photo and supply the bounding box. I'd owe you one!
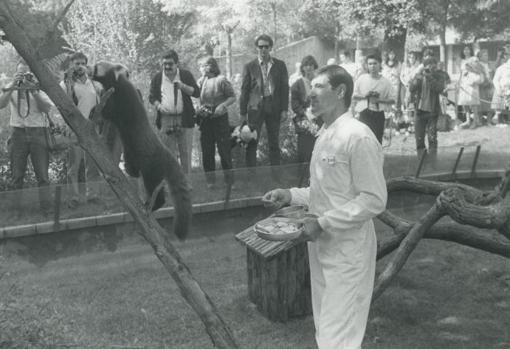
[10,127,51,210]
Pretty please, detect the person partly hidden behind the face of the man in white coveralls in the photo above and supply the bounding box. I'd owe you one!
[290,56,321,182]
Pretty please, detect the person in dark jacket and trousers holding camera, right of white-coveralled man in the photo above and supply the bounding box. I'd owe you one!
[409,57,446,156]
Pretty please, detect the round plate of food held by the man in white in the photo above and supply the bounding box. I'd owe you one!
[254,217,303,241]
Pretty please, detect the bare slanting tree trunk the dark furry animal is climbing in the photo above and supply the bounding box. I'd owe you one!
[0,1,237,349]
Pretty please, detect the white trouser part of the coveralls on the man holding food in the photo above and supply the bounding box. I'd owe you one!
[308,228,377,349]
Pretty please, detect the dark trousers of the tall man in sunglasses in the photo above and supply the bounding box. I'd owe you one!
[246,98,281,167]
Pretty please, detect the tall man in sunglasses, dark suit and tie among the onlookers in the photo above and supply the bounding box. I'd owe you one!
[240,34,289,179]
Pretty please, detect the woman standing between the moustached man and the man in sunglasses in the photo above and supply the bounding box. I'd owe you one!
[197,57,236,189]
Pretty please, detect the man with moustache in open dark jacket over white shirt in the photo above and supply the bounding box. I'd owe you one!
[149,50,200,174]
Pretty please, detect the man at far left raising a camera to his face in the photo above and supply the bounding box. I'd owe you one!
[0,61,52,214]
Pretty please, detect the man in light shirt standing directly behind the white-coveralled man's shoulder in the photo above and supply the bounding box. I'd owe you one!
[352,55,395,143]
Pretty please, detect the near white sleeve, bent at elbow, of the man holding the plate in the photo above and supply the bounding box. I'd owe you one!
[319,137,388,231]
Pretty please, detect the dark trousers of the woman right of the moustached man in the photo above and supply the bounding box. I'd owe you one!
[200,114,234,184]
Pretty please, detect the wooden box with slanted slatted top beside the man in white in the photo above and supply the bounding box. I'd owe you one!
[235,227,312,322]
